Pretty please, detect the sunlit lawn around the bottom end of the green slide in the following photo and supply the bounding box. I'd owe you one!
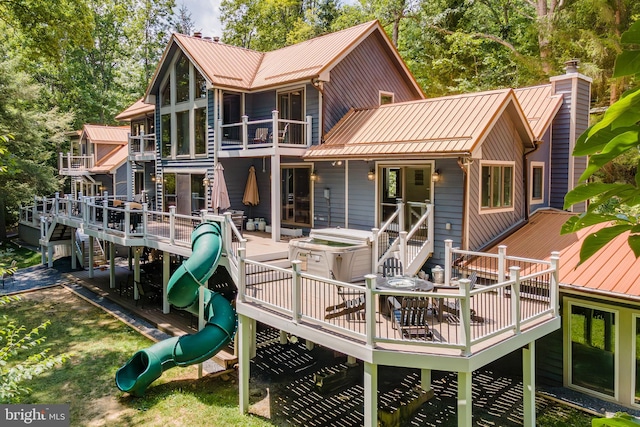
[0,288,273,426]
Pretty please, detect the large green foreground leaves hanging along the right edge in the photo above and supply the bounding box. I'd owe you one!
[562,21,640,262]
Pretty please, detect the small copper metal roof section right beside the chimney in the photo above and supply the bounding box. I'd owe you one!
[514,84,562,140]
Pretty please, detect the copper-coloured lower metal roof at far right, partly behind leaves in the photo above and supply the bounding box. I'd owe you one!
[486,210,640,297]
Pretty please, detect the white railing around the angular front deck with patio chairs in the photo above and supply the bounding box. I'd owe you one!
[238,242,559,356]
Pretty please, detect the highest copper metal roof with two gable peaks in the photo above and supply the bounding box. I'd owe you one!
[146,21,422,98]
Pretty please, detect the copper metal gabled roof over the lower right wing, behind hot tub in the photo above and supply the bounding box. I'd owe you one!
[304,89,533,160]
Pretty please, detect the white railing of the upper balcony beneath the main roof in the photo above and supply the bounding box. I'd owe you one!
[215,110,312,150]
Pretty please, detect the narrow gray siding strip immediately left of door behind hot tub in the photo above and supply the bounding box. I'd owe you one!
[347,160,376,230]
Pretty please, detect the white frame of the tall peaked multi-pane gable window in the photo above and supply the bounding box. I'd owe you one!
[160,50,209,160]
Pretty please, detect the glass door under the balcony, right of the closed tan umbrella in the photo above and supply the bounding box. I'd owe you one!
[281,167,311,226]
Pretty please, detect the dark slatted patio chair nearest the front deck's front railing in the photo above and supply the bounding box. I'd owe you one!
[388,297,433,340]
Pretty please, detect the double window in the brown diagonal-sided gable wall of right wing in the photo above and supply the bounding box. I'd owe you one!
[480,164,513,209]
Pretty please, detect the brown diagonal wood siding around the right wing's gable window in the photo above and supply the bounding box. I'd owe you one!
[468,115,524,250]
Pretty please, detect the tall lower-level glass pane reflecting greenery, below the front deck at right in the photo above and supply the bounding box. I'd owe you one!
[569,304,617,397]
